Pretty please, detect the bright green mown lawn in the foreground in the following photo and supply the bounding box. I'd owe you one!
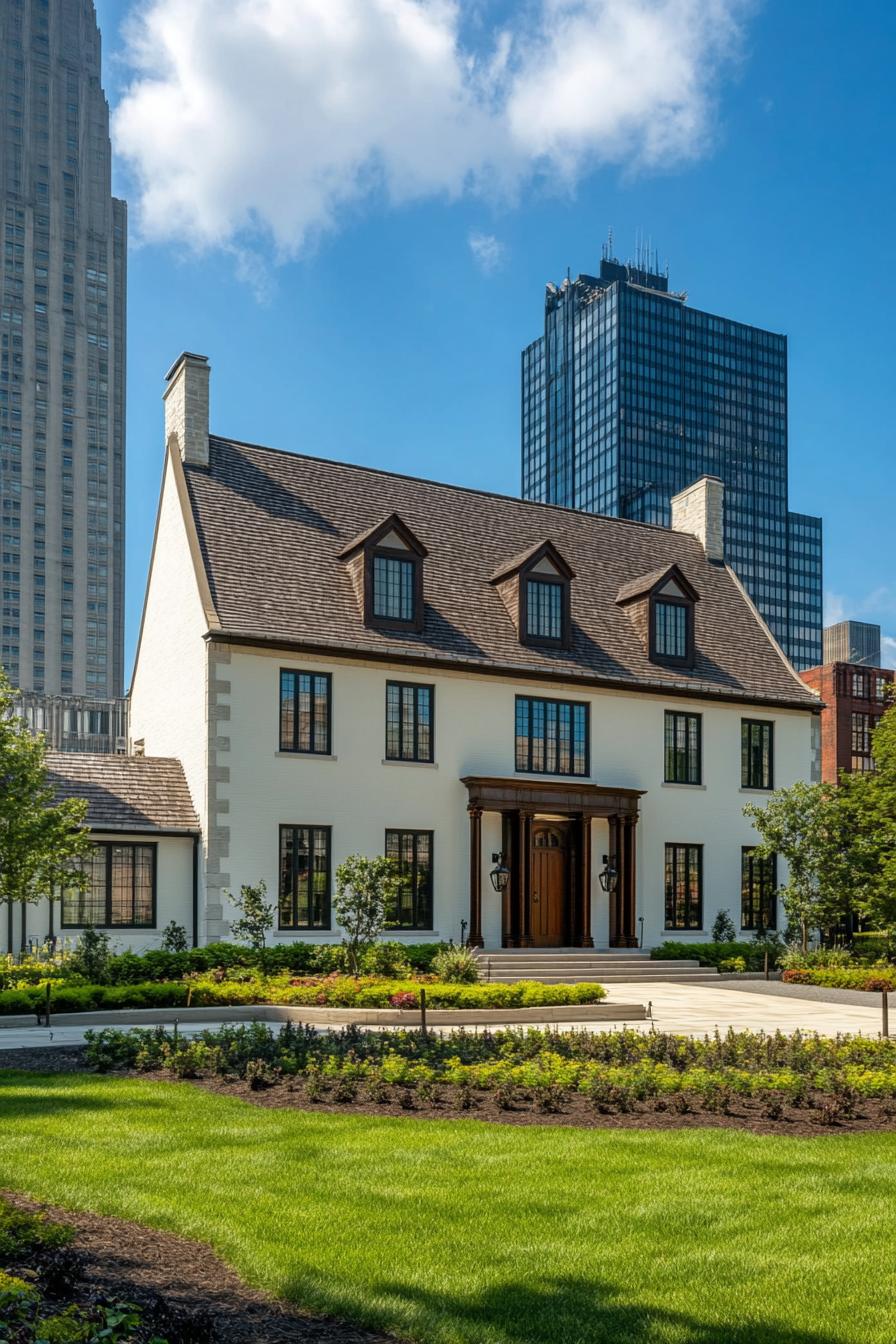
[0,1073,896,1344]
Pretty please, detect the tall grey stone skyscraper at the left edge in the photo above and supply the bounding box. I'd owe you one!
[0,0,126,699]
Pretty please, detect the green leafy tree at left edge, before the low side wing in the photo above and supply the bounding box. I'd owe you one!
[0,668,90,940]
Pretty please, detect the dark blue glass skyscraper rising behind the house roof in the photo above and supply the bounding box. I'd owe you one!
[523,250,822,668]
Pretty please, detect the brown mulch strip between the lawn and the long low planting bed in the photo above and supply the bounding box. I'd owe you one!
[0,1046,896,1138]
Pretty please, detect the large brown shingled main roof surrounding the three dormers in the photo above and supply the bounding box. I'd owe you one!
[176,437,819,710]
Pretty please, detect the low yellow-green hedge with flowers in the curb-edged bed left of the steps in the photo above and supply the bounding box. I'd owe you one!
[0,976,606,1016]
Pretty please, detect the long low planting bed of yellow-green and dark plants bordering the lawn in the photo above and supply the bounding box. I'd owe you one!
[75,1024,896,1130]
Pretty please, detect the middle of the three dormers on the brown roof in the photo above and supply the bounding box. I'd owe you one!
[492,542,575,649]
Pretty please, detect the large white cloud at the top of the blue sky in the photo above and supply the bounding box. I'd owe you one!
[114,0,748,266]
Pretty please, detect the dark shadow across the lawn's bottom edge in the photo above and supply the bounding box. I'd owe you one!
[349,1278,842,1344]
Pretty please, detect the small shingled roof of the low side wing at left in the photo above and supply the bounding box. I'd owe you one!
[47,751,199,833]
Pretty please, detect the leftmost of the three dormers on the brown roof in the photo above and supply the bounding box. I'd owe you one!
[340,513,426,632]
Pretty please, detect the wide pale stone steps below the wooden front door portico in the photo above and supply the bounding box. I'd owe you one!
[477,948,717,985]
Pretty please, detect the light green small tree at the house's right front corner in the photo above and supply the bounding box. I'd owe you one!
[744,781,861,952]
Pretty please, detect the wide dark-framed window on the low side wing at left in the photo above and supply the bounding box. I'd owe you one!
[62,840,159,929]
